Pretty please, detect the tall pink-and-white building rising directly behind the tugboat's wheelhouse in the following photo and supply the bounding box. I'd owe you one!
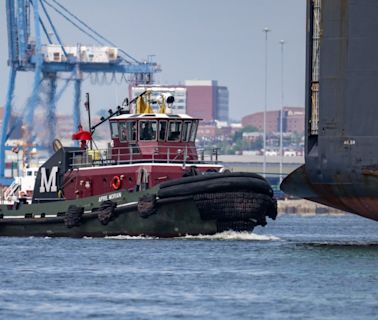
[130,80,229,122]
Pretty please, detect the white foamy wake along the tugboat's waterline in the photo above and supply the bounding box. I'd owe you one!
[105,231,281,241]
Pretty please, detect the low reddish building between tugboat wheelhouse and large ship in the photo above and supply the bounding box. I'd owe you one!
[242,107,305,134]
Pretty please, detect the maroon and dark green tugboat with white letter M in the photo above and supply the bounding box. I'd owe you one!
[0,91,277,237]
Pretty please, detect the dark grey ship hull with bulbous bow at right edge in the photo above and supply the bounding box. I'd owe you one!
[281,0,378,220]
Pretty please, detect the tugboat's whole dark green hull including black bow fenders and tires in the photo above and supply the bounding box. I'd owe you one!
[0,174,277,238]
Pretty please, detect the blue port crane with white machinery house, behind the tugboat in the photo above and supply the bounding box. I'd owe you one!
[0,0,160,182]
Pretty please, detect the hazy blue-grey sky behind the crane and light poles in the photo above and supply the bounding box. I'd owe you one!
[0,0,306,119]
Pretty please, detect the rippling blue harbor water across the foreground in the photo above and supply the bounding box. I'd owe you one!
[0,215,378,320]
